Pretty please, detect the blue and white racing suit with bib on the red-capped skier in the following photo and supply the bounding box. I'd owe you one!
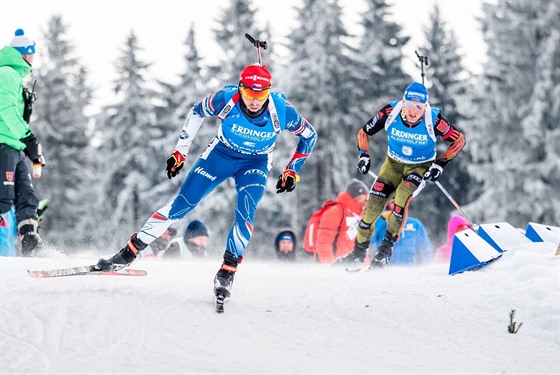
[133,86,317,258]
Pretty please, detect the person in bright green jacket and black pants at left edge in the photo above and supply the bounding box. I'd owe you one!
[0,29,45,256]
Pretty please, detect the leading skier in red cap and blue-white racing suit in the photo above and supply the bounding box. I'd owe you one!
[97,35,317,312]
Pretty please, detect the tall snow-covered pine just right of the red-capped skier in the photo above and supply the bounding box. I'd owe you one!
[287,0,367,241]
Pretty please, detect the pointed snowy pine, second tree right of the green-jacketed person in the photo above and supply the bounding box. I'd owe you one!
[93,32,162,245]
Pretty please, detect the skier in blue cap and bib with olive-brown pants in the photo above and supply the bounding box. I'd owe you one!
[338,82,466,267]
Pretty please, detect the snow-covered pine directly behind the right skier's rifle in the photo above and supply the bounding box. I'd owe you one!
[410,4,475,243]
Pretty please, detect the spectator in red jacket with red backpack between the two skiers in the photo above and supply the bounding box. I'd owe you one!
[306,178,369,264]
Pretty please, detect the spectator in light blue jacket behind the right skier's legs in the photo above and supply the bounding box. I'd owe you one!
[370,202,433,266]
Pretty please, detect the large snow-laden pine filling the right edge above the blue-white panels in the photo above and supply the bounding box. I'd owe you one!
[466,0,560,228]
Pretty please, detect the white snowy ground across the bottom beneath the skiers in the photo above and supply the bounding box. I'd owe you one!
[0,243,560,375]
